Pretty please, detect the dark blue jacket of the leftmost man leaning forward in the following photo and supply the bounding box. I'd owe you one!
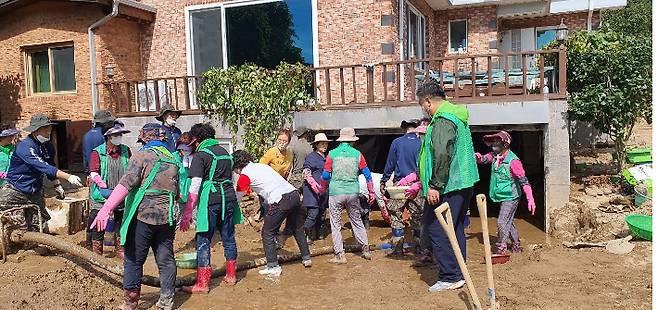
[7,135,57,195]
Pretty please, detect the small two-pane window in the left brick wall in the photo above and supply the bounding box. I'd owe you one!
[27,46,75,94]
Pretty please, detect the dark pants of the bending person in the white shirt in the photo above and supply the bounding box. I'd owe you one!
[261,190,311,267]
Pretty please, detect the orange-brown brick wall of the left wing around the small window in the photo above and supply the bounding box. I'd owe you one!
[0,2,141,127]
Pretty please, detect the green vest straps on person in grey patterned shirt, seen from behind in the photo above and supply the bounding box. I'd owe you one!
[119,146,183,245]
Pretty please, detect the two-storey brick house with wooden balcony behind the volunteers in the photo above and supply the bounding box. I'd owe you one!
[0,0,626,226]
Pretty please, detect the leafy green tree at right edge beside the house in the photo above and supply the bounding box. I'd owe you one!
[566,29,651,170]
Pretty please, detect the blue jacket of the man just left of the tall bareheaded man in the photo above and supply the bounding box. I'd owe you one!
[382,133,421,182]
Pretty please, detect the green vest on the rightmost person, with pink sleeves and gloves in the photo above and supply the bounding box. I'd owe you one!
[489,151,521,202]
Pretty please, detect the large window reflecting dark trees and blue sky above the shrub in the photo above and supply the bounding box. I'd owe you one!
[186,0,314,75]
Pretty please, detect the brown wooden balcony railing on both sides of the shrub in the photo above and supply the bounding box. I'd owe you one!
[98,49,567,115]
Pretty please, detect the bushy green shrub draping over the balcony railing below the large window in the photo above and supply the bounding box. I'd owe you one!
[197,62,313,158]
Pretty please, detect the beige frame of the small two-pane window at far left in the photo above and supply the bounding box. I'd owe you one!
[21,42,78,97]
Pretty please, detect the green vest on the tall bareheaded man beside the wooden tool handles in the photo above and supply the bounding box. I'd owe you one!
[418,101,480,197]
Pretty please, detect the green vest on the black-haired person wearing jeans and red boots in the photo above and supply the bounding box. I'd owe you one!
[196,139,244,233]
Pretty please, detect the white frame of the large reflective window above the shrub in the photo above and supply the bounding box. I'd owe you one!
[185,0,320,75]
